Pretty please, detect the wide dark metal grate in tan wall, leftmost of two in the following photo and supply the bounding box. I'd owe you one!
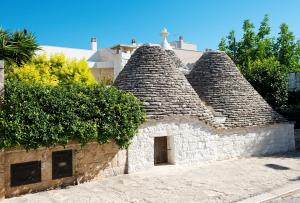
[10,161,41,187]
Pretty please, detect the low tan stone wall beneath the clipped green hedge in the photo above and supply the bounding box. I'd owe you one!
[0,143,127,199]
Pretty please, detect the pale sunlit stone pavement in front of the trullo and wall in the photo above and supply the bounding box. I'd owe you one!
[1,152,300,203]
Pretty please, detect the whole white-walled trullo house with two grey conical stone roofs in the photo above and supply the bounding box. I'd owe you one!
[114,46,294,173]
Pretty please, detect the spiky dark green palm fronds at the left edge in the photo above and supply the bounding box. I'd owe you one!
[0,28,39,65]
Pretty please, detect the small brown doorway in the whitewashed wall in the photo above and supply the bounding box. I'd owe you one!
[154,137,168,165]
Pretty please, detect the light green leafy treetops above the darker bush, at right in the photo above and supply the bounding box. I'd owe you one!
[219,15,300,74]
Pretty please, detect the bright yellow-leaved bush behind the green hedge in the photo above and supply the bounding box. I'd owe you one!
[7,54,95,85]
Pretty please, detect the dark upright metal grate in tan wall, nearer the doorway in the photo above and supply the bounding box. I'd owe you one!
[52,150,73,179]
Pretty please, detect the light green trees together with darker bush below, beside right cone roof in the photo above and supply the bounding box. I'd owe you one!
[219,15,300,110]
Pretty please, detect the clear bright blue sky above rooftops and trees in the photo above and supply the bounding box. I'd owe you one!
[0,0,300,50]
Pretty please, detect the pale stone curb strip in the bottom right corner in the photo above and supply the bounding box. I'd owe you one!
[237,181,300,203]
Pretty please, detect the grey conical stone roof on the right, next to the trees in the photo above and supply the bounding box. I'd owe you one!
[187,51,286,128]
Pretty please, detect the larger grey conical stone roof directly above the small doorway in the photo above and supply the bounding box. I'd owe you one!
[114,46,215,126]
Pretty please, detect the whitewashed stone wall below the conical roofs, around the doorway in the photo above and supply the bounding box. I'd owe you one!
[128,118,295,173]
